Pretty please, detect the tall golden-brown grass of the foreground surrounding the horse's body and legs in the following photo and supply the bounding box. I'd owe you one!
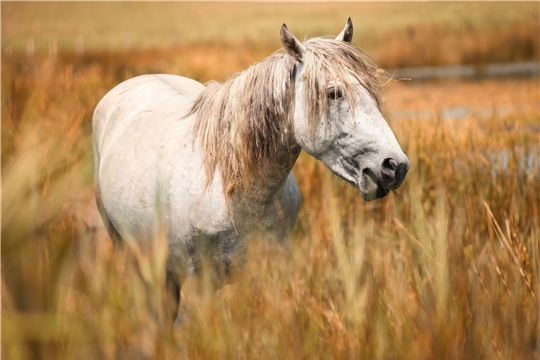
[2,41,540,359]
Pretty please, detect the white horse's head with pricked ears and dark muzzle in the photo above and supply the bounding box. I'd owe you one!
[281,18,409,201]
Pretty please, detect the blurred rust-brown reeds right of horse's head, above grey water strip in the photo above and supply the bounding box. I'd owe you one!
[374,14,540,68]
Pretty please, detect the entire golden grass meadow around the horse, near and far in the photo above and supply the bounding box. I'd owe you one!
[1,3,540,359]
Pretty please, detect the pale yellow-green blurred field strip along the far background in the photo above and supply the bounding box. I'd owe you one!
[2,2,539,51]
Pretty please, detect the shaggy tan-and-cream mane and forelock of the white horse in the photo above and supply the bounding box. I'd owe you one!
[188,38,382,195]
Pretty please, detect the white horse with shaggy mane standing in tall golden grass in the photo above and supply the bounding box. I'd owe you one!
[93,18,409,324]
